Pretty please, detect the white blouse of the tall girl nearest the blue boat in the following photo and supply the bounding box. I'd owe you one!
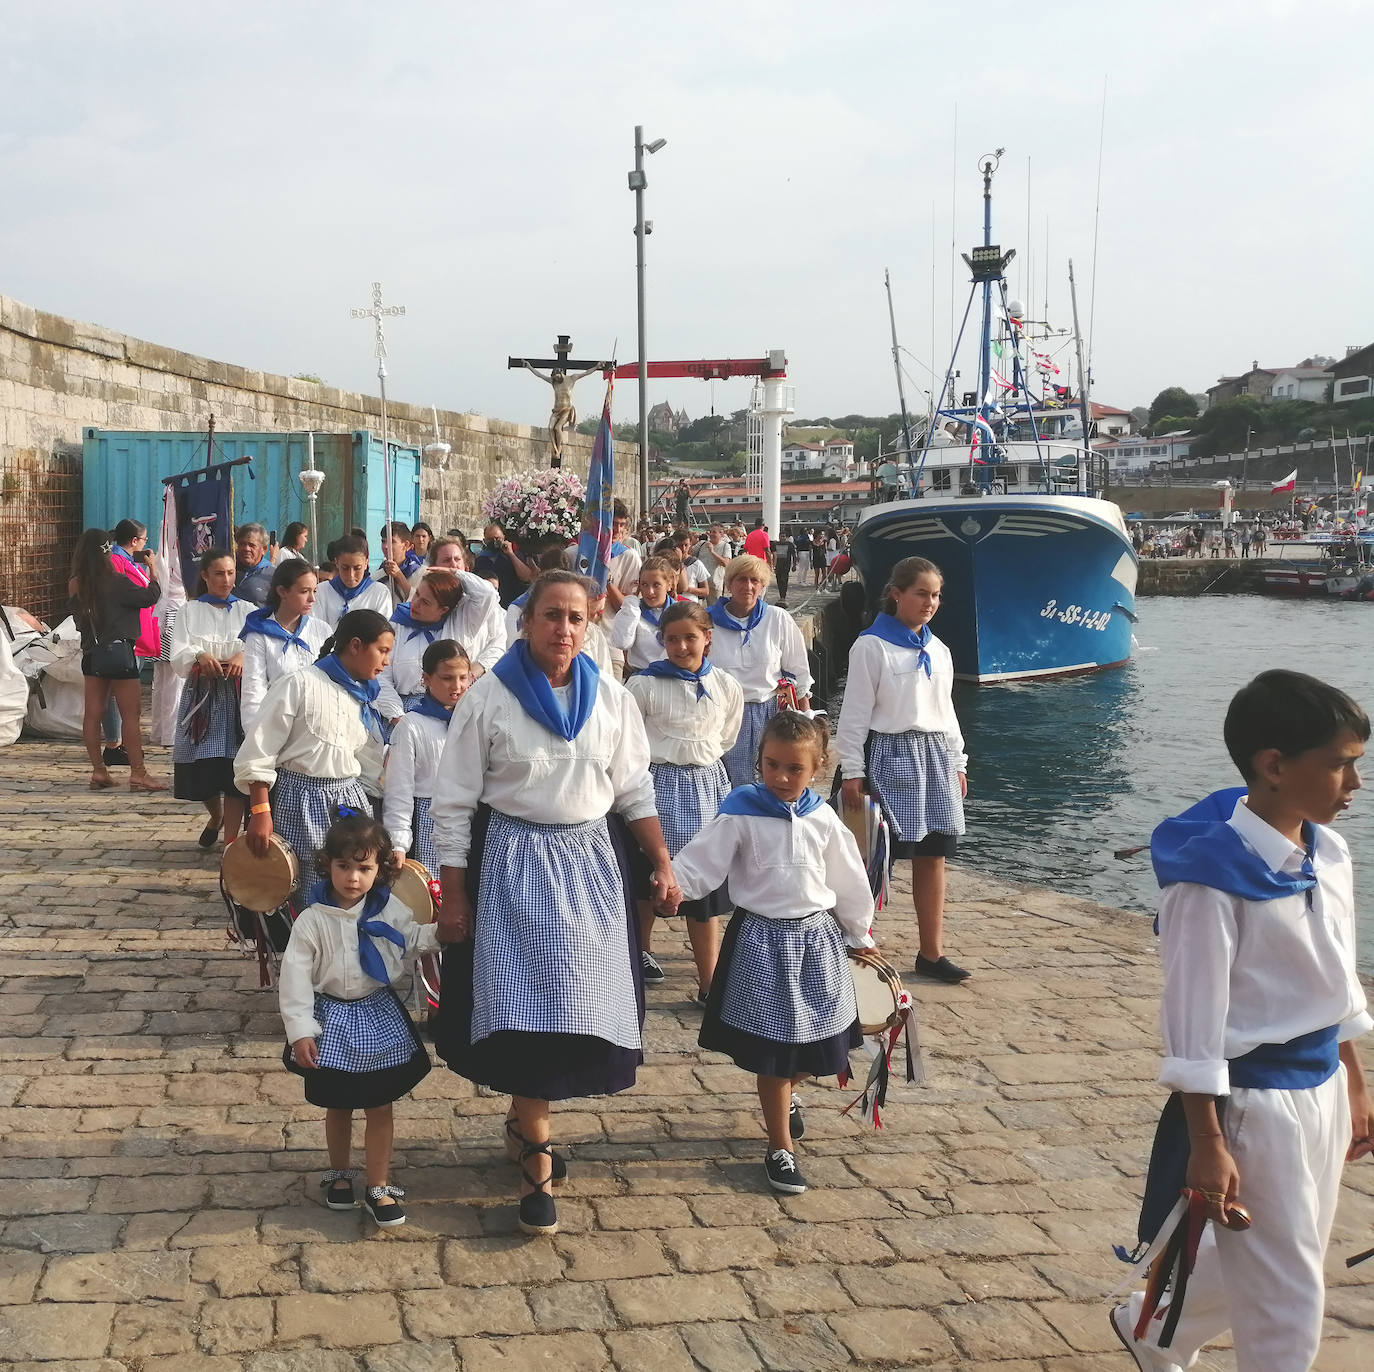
[829,633,969,779]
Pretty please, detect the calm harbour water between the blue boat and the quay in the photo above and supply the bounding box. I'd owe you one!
[955,596,1374,974]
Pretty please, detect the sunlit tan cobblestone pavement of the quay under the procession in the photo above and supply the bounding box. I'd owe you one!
[0,742,1374,1372]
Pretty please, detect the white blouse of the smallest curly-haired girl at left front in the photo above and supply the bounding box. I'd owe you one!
[276,895,438,1044]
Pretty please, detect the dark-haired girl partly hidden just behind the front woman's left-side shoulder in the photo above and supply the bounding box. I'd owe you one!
[382,639,473,878]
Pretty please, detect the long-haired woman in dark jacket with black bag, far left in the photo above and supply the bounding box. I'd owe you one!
[70,529,166,791]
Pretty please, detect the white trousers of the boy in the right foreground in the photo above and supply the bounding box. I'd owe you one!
[1131,1066,1351,1372]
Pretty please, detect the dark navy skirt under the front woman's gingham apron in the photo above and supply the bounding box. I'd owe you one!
[434,805,644,1100]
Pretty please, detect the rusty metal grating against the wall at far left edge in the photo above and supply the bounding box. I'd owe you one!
[0,453,81,624]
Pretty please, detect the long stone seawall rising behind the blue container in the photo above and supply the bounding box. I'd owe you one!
[0,295,638,618]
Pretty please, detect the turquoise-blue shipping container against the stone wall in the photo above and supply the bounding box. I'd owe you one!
[81,428,420,556]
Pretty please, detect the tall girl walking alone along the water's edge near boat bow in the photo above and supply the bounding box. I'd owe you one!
[837,558,969,983]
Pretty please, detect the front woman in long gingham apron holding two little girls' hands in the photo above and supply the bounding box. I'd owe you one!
[431,571,680,1233]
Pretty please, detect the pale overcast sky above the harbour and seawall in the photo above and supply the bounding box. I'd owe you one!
[0,0,1374,423]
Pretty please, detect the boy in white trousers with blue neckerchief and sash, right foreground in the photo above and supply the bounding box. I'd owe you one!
[1112,670,1374,1372]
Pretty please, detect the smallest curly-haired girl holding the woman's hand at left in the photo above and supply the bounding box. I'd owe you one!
[278,814,437,1229]
